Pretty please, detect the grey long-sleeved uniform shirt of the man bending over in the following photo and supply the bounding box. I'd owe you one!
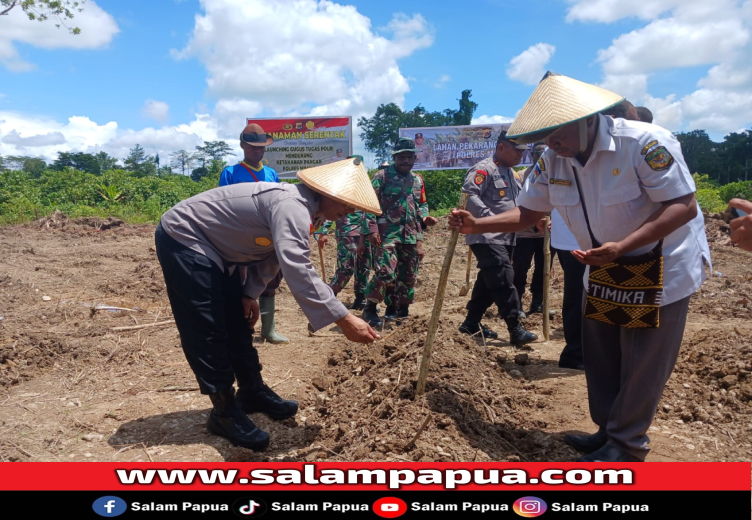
[161,182,349,330]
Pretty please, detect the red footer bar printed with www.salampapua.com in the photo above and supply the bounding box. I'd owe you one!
[0,462,752,491]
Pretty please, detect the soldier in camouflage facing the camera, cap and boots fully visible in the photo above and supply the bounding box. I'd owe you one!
[362,137,436,327]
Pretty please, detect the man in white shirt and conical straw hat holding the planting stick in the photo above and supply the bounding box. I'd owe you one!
[450,73,710,462]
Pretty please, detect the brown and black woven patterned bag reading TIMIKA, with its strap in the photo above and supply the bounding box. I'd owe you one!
[575,168,663,329]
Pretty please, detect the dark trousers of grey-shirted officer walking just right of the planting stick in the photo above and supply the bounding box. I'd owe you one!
[465,244,520,327]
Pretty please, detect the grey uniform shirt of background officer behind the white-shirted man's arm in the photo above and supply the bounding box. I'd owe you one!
[462,157,519,246]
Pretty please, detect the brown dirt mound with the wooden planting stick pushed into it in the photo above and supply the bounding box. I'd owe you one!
[280,318,573,461]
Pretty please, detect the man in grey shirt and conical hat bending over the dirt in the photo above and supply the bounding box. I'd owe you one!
[155,158,381,451]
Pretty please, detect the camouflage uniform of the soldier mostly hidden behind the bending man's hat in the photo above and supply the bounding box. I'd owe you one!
[329,211,371,294]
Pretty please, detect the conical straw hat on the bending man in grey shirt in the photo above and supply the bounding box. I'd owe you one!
[298,157,381,215]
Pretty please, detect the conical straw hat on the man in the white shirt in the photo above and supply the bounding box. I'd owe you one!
[507,72,624,144]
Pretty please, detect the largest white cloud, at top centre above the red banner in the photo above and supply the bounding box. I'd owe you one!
[173,0,433,117]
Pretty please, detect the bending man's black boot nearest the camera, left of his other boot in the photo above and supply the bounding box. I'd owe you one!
[206,387,269,451]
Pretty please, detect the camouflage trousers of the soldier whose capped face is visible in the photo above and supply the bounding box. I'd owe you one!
[366,244,420,305]
